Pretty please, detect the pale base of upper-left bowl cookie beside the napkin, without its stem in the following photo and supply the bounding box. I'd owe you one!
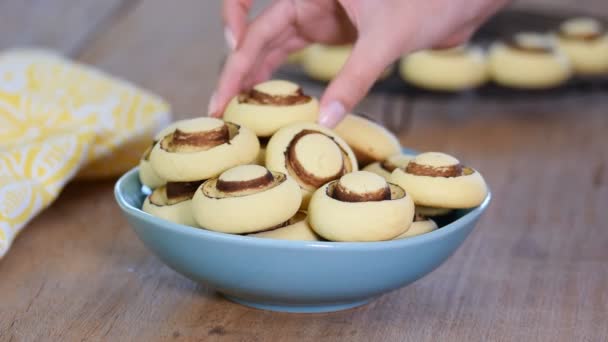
[150,123,260,182]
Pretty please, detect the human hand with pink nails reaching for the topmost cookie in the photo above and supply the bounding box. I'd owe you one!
[209,0,509,127]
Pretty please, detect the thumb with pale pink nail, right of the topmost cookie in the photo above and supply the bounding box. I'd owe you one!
[319,37,393,128]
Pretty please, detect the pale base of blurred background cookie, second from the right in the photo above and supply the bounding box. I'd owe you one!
[489,43,571,89]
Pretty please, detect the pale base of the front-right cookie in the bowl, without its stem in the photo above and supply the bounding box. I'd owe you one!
[308,184,414,241]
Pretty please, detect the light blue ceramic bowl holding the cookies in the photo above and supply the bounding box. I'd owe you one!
[115,168,490,312]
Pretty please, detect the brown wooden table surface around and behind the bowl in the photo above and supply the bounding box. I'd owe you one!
[0,0,608,341]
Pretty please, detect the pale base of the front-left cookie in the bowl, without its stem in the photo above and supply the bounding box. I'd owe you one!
[192,177,302,234]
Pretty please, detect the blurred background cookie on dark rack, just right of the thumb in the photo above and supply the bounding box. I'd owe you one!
[399,45,488,91]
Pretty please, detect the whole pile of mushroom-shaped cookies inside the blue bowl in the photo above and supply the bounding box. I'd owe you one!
[139,80,487,241]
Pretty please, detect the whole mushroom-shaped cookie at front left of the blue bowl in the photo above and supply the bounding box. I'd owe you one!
[192,165,302,234]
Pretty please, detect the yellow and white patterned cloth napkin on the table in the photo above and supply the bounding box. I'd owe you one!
[0,50,170,258]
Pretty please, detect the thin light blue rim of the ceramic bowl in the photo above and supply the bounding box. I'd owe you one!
[114,166,492,251]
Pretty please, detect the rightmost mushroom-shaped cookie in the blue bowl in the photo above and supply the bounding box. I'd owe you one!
[391,152,488,209]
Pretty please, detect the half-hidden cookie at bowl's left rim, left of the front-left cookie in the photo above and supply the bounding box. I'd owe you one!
[142,185,198,227]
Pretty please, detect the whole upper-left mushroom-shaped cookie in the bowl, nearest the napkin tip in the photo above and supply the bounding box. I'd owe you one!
[150,117,260,182]
